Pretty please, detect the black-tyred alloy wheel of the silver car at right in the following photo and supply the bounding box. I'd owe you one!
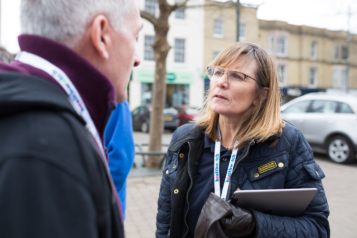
[327,136,355,164]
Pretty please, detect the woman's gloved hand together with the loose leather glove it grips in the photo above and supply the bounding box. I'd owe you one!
[195,193,255,238]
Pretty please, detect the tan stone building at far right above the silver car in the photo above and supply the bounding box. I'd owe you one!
[259,20,357,99]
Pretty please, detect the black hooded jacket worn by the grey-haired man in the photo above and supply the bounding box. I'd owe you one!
[0,73,124,238]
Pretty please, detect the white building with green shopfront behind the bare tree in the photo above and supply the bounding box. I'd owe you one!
[129,0,204,110]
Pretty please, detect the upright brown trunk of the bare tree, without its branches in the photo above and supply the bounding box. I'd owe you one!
[146,7,171,168]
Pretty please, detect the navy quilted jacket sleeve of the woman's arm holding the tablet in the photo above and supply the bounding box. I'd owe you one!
[253,131,330,238]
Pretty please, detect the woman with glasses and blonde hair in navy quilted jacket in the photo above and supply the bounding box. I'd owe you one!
[156,42,330,238]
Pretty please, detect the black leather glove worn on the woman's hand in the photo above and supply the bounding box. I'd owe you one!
[219,203,255,237]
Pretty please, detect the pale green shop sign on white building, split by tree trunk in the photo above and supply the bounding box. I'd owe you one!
[135,69,194,84]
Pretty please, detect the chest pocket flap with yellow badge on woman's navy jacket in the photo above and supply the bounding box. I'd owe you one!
[245,152,289,182]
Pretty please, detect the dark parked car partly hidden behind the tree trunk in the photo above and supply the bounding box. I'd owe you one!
[131,105,179,133]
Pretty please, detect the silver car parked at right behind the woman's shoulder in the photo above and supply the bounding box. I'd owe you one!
[281,93,357,163]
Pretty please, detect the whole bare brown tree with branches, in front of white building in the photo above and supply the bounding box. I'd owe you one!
[141,0,234,168]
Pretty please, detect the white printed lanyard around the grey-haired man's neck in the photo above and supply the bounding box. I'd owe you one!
[15,51,106,158]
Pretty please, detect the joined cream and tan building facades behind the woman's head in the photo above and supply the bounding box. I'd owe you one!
[204,1,357,96]
